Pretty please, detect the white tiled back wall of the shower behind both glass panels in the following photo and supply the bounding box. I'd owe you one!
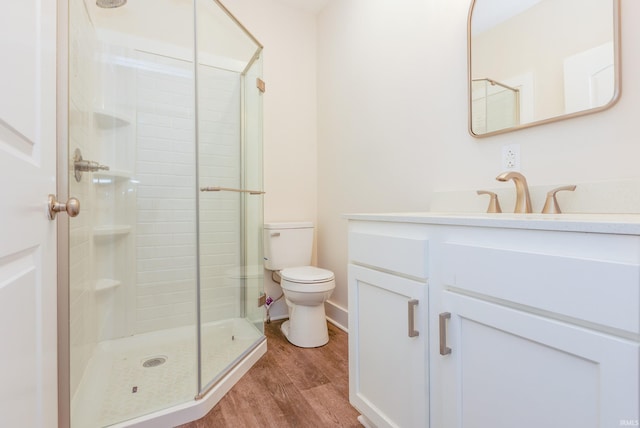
[135,53,240,333]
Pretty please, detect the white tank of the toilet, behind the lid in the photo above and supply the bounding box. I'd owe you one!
[263,222,313,270]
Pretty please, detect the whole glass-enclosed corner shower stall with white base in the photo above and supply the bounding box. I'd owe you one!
[60,0,266,428]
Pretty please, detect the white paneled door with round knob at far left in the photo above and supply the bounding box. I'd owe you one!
[0,0,58,427]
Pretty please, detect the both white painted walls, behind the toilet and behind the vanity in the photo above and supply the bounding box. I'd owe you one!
[225,0,640,328]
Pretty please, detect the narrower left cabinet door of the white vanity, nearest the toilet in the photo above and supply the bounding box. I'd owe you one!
[349,265,429,428]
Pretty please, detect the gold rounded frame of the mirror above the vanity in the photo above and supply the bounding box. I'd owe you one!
[467,0,622,138]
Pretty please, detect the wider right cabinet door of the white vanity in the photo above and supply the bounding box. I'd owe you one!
[439,291,640,428]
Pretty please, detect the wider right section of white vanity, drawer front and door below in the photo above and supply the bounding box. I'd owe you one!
[438,237,640,428]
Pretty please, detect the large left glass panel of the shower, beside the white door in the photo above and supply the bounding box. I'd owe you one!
[67,0,198,428]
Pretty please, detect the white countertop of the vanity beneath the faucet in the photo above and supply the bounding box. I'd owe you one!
[344,212,640,235]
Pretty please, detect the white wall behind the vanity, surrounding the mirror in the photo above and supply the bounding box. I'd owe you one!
[318,0,640,322]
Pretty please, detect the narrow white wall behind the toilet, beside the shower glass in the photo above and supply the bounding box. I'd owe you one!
[223,0,317,318]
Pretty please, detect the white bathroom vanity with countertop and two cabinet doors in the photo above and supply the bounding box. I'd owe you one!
[349,214,640,428]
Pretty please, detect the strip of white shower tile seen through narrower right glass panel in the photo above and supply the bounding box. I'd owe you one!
[198,66,243,322]
